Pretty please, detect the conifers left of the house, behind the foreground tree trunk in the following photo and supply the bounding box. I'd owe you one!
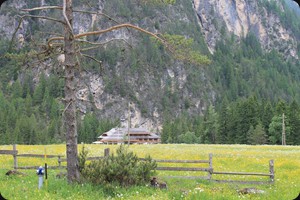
[0,73,117,144]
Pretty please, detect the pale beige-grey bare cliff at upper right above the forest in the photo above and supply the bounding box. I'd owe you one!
[194,0,298,59]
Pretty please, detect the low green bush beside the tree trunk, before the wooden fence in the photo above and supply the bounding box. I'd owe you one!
[79,145,157,187]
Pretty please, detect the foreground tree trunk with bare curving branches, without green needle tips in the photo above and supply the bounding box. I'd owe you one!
[21,0,167,183]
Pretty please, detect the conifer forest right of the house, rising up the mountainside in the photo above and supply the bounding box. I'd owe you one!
[161,27,300,145]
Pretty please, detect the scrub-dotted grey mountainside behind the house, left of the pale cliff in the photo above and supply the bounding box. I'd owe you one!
[1,0,215,132]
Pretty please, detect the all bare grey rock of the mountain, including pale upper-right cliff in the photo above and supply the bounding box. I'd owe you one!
[0,0,298,130]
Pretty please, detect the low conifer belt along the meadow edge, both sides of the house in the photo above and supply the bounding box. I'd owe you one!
[0,65,300,145]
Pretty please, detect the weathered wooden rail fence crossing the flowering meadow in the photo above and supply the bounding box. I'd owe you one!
[0,145,275,184]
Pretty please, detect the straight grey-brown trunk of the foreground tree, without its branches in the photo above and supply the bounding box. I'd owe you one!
[64,0,79,183]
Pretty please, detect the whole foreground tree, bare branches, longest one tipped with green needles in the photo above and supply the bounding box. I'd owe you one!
[14,0,208,183]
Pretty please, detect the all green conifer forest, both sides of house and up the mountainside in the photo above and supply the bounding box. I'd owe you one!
[0,30,300,144]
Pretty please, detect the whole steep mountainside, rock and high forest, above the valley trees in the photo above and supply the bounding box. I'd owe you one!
[0,0,300,139]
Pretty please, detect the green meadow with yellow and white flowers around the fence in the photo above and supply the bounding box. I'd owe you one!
[0,144,300,200]
